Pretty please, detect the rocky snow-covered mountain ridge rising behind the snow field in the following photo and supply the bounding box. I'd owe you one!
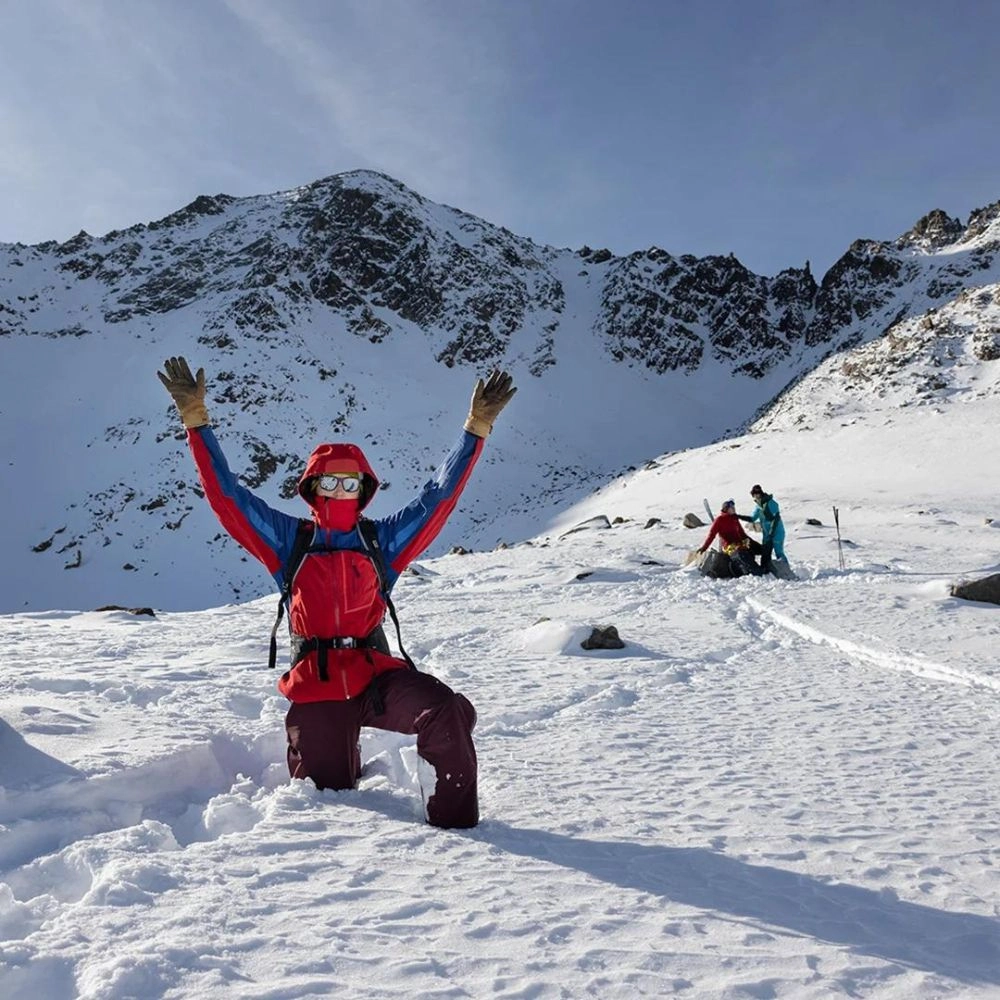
[0,172,1000,610]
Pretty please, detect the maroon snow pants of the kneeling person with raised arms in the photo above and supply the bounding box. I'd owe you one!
[285,670,479,827]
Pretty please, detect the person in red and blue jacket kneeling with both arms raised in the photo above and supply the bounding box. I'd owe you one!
[157,357,517,827]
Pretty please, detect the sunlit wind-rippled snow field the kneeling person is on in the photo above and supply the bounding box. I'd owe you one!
[0,400,1000,1000]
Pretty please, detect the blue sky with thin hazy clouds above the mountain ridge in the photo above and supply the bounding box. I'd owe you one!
[0,0,1000,277]
